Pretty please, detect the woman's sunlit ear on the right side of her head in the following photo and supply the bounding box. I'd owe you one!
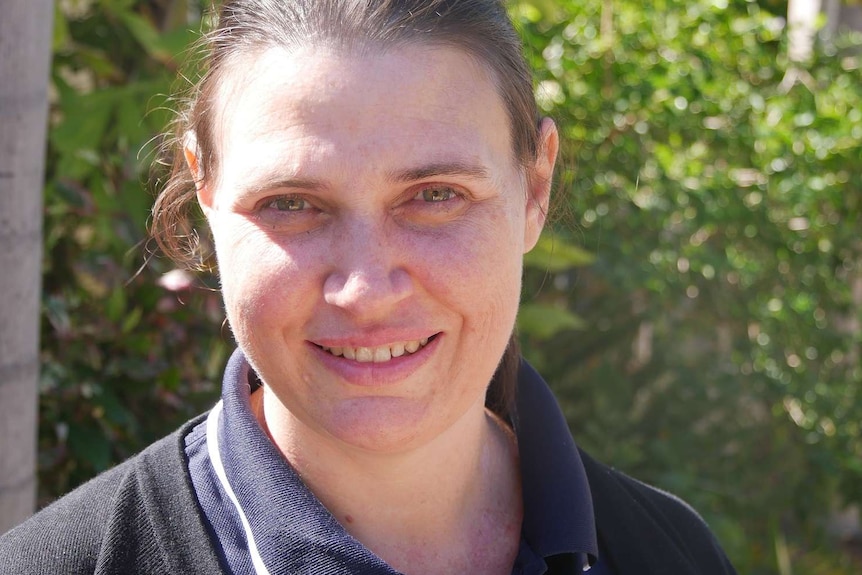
[524,118,560,253]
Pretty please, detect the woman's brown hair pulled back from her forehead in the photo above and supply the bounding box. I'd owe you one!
[150,0,540,419]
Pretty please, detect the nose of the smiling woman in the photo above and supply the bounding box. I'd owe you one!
[323,220,413,321]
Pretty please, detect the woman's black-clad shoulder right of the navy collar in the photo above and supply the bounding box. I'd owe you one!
[581,451,735,575]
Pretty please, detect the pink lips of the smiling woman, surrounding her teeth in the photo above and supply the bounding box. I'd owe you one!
[308,332,443,387]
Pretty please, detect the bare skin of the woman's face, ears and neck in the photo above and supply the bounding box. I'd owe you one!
[191,45,557,573]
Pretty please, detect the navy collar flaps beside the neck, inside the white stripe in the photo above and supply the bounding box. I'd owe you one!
[218,350,598,574]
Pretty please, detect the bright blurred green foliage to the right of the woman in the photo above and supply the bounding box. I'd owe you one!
[514,0,862,573]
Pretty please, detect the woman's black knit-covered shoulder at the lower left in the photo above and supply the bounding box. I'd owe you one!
[0,418,216,575]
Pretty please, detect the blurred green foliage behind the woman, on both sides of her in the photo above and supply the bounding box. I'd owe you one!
[40,0,862,575]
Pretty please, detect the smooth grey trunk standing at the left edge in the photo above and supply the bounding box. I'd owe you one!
[0,0,53,533]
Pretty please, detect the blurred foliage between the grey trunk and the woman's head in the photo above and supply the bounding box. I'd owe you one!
[39,0,230,501]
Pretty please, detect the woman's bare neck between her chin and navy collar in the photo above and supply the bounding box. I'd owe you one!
[252,390,523,573]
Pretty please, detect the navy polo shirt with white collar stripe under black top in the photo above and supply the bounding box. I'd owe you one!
[186,350,612,575]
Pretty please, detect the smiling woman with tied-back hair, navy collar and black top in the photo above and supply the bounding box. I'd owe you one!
[0,0,733,575]
